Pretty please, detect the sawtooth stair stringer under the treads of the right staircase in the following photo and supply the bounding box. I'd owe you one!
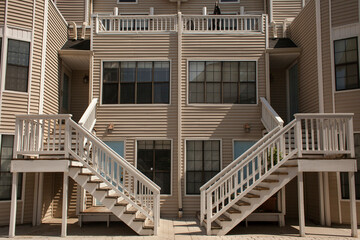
[215,167,298,236]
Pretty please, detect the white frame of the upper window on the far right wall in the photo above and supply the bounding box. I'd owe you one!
[331,35,360,92]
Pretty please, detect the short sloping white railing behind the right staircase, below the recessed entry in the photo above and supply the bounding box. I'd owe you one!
[260,97,284,131]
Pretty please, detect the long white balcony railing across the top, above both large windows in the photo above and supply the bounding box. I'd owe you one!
[93,14,267,34]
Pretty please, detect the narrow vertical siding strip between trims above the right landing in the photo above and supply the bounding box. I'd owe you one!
[320,1,333,113]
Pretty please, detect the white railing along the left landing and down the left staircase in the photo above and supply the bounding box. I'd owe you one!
[14,115,160,234]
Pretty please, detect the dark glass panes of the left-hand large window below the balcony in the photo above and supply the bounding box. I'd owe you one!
[102,62,170,104]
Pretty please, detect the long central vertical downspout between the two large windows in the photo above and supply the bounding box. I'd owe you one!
[177,10,183,218]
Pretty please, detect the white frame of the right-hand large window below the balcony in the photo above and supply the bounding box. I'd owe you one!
[186,58,259,107]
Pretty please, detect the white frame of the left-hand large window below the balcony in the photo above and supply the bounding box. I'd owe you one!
[100,58,172,107]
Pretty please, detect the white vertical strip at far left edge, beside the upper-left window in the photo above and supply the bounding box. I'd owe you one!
[0,0,9,126]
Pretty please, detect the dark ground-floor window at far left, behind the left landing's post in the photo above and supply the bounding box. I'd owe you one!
[0,135,22,200]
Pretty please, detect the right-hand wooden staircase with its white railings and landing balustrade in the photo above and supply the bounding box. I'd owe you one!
[200,99,354,235]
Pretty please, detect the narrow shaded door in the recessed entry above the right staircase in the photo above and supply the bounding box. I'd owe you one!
[288,63,299,121]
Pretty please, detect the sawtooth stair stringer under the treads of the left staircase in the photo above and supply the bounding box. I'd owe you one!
[69,168,154,235]
